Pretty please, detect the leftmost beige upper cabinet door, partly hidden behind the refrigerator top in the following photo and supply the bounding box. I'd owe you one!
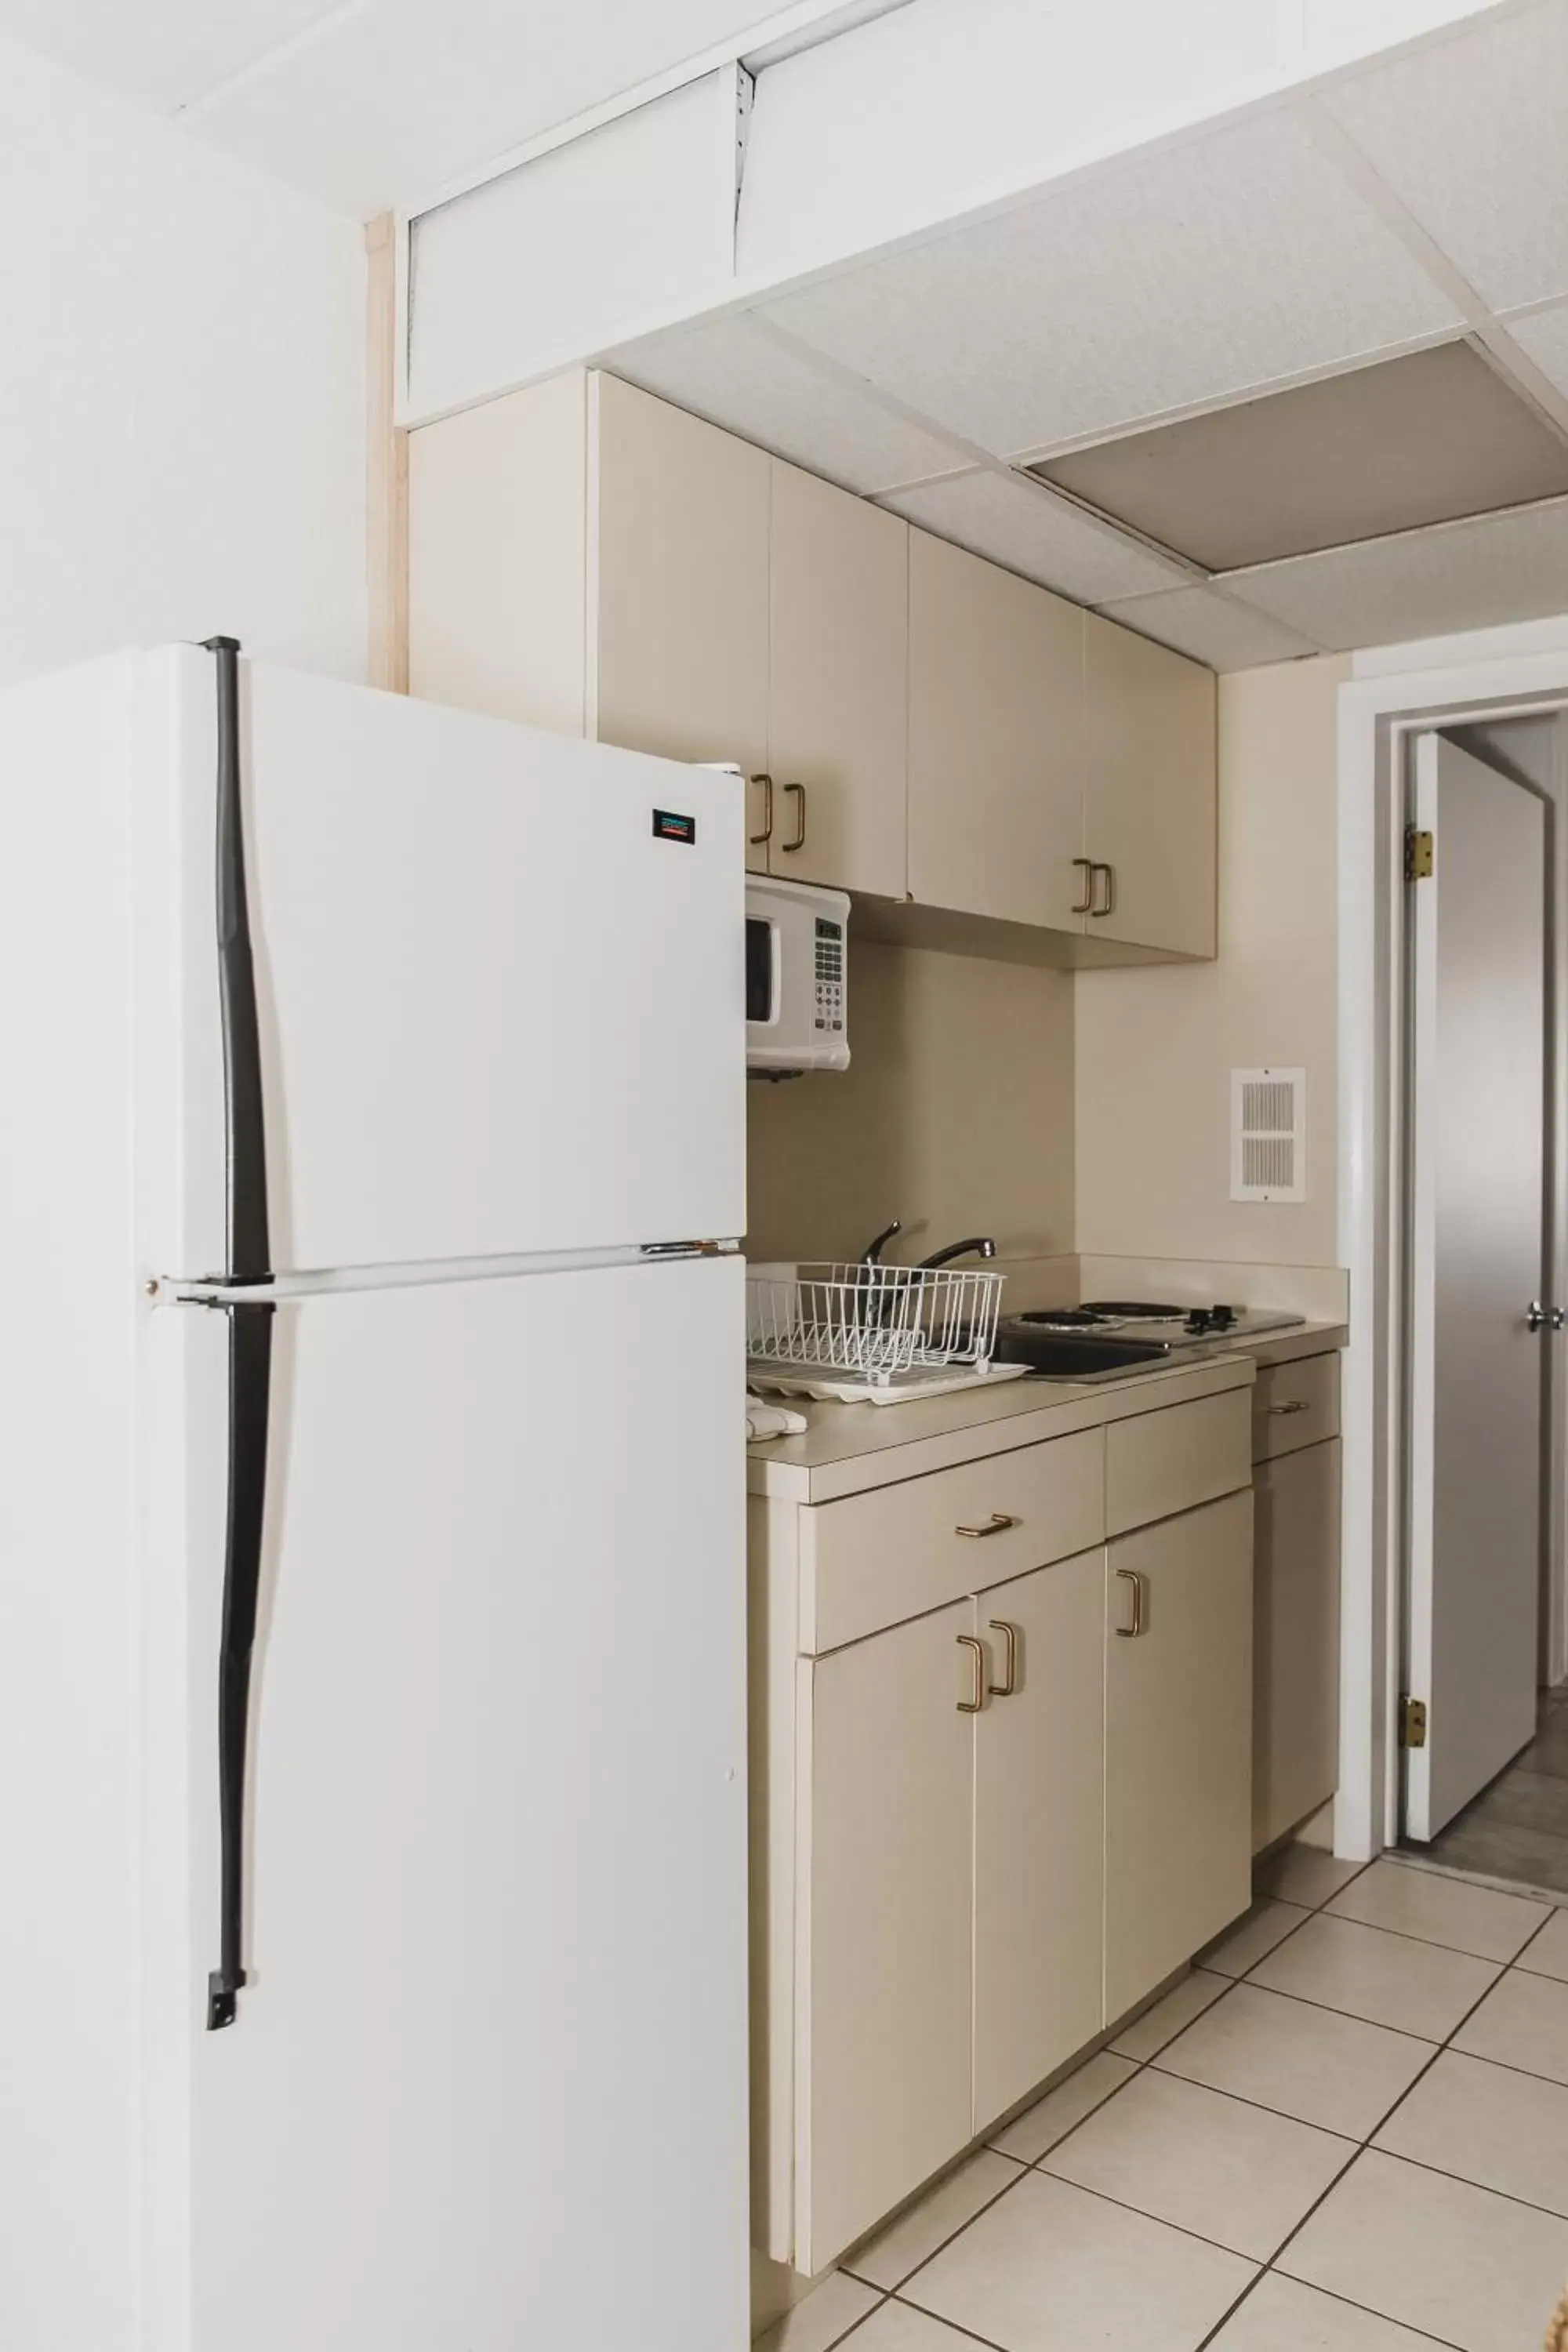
[588,374,775,880]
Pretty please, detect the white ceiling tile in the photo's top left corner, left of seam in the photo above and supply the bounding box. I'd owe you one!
[0,0,341,113]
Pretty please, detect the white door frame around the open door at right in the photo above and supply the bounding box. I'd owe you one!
[1333,621,1568,1860]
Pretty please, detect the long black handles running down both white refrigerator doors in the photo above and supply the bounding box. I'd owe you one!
[205,637,273,2032]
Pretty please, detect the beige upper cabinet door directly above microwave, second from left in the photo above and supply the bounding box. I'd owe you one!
[771,461,909,898]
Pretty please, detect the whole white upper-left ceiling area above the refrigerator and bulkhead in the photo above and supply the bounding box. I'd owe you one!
[0,0,822,216]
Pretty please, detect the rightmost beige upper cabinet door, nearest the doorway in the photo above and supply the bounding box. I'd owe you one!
[1083,614,1215,955]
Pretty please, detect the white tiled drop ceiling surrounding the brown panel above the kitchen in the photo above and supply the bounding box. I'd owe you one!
[607,0,1568,670]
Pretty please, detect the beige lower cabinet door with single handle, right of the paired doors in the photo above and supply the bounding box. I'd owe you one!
[1105,1494,1253,2023]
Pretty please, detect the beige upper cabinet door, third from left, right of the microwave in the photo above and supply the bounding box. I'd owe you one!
[909,532,1086,931]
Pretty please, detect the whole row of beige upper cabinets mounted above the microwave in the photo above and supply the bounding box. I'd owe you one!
[409,369,1215,941]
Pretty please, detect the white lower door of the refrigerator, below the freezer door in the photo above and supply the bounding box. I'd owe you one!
[146,1261,748,2352]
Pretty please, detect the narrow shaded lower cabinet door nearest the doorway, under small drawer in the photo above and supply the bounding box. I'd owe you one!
[1253,1437,1340,1851]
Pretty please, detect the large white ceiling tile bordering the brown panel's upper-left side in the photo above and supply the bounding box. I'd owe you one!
[764,113,1460,456]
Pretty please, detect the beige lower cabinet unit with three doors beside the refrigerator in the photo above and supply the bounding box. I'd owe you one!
[775,1388,1253,2272]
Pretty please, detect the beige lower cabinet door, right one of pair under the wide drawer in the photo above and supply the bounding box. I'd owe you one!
[973,1548,1105,2131]
